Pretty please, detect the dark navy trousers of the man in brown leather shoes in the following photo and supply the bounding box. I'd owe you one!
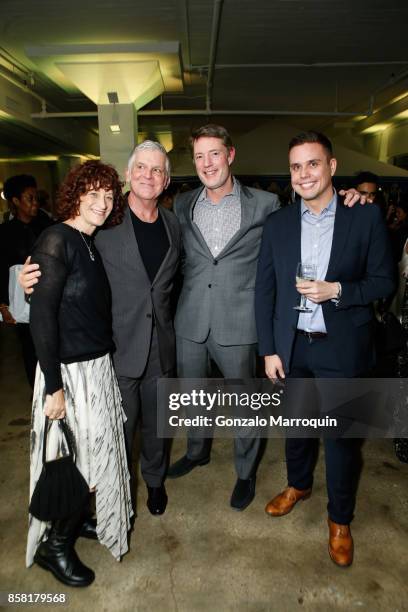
[286,334,361,525]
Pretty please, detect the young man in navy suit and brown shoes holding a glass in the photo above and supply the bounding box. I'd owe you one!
[255,132,394,566]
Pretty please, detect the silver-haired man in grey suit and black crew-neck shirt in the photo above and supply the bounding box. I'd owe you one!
[21,140,181,515]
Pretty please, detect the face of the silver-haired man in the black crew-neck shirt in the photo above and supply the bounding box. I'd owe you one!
[127,149,170,201]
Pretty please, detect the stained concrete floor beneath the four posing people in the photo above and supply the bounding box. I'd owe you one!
[0,325,408,612]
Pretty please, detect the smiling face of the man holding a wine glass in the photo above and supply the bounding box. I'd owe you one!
[289,142,337,209]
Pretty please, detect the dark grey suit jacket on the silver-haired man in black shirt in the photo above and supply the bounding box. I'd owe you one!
[96,206,181,378]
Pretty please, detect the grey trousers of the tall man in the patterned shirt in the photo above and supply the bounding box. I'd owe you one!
[176,333,261,480]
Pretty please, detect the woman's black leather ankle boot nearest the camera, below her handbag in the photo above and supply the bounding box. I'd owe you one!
[34,511,95,587]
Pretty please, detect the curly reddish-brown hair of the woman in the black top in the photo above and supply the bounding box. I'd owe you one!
[56,160,125,227]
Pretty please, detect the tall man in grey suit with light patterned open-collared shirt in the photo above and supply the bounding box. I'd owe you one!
[168,124,279,510]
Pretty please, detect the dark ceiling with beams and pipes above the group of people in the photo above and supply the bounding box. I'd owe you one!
[0,0,408,160]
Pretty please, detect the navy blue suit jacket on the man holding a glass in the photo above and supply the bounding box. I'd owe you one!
[255,197,395,377]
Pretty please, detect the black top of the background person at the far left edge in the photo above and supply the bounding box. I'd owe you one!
[0,211,53,304]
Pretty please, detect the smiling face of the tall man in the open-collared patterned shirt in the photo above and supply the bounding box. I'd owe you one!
[193,136,235,191]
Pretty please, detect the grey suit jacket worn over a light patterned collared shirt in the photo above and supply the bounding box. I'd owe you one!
[174,180,279,346]
